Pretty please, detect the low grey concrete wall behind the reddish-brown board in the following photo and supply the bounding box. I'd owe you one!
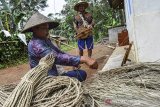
[108,26,126,43]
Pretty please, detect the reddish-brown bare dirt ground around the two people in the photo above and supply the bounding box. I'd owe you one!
[0,45,113,85]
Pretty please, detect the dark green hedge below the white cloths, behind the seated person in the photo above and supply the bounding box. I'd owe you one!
[0,33,30,68]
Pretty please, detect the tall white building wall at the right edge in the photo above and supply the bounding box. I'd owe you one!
[125,0,160,62]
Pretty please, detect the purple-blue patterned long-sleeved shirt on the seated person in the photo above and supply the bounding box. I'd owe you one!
[28,37,80,76]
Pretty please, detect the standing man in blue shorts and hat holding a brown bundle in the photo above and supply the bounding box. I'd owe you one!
[73,1,94,57]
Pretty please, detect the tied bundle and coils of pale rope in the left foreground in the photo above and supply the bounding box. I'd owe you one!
[0,54,98,107]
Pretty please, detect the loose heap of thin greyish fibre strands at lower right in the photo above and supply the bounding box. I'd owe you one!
[83,63,160,107]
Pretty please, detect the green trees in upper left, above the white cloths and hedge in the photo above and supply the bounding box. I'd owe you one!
[0,0,47,33]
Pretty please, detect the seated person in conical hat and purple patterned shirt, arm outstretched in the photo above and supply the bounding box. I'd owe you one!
[22,12,98,81]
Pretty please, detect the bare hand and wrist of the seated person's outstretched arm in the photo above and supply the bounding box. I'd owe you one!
[81,56,98,69]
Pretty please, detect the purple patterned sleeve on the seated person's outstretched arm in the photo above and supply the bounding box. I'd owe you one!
[33,42,80,66]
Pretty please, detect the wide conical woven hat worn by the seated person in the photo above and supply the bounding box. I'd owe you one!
[21,12,59,33]
